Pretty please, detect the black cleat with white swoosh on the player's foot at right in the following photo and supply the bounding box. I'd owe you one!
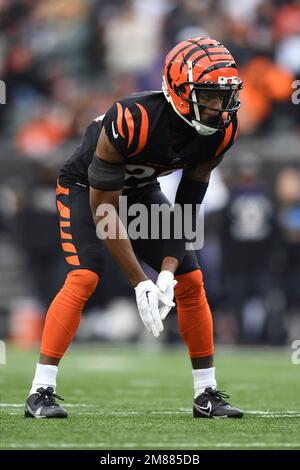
[193,387,244,418]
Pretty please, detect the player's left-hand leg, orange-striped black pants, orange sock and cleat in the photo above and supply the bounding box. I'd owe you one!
[25,184,105,417]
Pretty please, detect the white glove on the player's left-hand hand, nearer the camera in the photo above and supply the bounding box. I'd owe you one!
[134,279,164,337]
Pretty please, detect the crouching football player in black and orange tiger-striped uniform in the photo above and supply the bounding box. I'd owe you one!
[25,37,243,418]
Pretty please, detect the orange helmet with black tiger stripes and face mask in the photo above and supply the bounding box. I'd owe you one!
[162,37,243,135]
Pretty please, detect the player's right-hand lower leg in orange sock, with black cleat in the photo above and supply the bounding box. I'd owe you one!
[175,260,243,418]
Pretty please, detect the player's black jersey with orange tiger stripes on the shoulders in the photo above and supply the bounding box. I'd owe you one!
[60,92,238,190]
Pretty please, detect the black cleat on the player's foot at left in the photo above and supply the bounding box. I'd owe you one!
[25,387,68,418]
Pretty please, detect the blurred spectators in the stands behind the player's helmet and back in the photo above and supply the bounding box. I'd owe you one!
[0,0,300,151]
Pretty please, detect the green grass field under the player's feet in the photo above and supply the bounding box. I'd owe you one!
[0,346,300,450]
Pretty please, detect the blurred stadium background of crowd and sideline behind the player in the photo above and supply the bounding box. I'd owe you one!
[0,0,300,347]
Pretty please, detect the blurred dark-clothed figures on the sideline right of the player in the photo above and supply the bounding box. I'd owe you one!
[198,161,300,344]
